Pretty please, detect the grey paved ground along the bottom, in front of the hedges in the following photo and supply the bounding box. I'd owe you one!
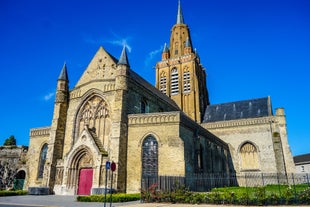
[0,195,304,207]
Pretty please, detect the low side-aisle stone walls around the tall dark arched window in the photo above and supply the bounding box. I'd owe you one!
[126,112,229,193]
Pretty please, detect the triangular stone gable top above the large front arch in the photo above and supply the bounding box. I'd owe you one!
[76,46,117,87]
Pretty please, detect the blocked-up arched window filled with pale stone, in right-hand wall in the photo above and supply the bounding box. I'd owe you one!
[240,142,259,170]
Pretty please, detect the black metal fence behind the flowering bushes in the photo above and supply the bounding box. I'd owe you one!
[141,173,310,192]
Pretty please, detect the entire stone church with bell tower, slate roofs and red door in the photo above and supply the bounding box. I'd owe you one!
[26,3,294,195]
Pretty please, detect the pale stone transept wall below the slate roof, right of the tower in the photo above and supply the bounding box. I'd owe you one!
[202,108,295,173]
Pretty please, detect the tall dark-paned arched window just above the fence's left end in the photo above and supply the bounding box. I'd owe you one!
[142,136,158,177]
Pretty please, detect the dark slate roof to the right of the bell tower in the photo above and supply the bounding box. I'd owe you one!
[203,96,272,123]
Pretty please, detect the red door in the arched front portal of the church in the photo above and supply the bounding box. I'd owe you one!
[78,168,93,195]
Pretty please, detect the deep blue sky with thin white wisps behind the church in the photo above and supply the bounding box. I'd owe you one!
[0,0,310,155]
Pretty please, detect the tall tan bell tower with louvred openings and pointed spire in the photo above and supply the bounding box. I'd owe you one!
[156,1,210,123]
